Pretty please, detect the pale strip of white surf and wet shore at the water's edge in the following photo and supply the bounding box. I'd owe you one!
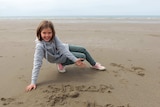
[0,17,160,24]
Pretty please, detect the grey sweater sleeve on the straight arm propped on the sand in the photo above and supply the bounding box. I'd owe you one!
[31,44,44,84]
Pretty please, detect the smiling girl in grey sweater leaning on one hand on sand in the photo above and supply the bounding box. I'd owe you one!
[26,20,105,91]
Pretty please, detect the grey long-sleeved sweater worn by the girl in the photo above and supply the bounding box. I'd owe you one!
[31,36,77,84]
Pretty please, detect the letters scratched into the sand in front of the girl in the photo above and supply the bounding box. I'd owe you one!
[42,84,114,107]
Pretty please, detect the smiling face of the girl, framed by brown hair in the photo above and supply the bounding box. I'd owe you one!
[41,28,53,42]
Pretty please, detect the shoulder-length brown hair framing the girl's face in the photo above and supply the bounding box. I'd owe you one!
[37,20,55,41]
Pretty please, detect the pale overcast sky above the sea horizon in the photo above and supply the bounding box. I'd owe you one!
[0,0,160,16]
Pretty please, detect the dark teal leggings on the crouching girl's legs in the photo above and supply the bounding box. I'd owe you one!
[62,45,96,66]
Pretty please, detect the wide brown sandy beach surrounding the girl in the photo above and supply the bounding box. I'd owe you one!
[0,19,160,107]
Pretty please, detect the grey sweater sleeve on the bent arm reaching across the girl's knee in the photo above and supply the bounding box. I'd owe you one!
[54,36,77,62]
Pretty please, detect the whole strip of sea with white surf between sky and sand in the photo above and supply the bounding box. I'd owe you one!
[0,15,160,23]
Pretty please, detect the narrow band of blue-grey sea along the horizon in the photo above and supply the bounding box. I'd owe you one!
[0,15,160,19]
